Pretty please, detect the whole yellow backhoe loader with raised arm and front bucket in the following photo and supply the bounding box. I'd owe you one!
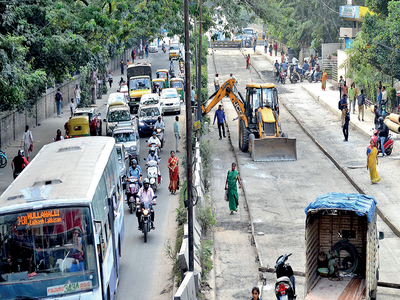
[202,78,297,161]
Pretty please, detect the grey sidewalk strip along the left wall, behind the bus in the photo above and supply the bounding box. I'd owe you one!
[0,68,125,195]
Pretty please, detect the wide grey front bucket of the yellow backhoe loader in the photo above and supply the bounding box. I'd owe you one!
[249,134,297,161]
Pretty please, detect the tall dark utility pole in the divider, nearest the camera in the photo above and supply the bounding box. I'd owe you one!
[184,0,194,272]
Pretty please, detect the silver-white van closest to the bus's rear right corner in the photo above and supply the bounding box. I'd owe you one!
[112,125,140,161]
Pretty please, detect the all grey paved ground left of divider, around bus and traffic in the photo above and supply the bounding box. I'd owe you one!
[0,45,181,300]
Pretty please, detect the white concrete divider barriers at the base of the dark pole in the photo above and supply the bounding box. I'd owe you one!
[174,142,205,300]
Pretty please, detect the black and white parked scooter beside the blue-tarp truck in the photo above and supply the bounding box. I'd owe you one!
[274,253,296,300]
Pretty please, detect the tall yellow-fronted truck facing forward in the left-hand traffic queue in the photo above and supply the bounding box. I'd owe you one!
[126,62,152,114]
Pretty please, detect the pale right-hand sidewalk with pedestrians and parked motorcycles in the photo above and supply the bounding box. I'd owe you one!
[250,46,400,140]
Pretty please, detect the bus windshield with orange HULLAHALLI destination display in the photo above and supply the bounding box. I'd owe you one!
[0,207,98,299]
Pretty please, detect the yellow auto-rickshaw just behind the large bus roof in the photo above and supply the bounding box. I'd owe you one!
[64,107,103,137]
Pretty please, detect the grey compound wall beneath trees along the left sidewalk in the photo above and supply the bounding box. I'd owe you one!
[0,49,132,149]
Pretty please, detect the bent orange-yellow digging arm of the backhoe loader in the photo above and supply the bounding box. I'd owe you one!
[201,78,245,116]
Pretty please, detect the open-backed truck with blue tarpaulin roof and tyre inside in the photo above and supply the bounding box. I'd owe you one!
[305,193,379,300]
